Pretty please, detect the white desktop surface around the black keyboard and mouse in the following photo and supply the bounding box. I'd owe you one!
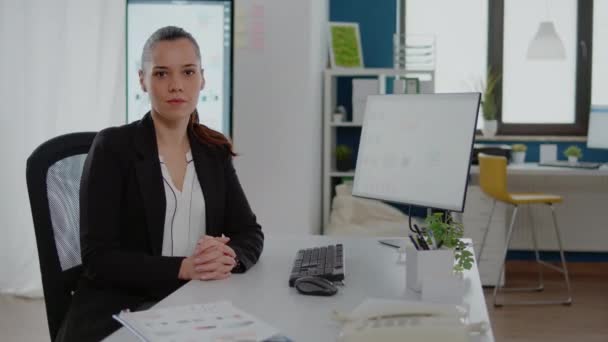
[106,236,494,342]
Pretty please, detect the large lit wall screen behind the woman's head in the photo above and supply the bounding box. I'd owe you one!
[127,0,232,135]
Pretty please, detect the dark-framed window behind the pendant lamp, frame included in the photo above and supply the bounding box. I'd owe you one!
[489,0,592,135]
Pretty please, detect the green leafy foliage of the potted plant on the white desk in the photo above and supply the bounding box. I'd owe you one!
[425,213,475,272]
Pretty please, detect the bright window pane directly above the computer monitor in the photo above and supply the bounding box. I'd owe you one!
[405,0,488,128]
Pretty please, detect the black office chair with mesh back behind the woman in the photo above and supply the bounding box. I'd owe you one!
[26,132,97,340]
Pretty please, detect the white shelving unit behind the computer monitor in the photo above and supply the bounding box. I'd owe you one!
[321,68,435,232]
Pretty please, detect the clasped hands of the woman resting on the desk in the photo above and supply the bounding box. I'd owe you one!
[179,235,236,280]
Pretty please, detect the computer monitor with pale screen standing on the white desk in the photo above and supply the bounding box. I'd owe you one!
[353,93,480,212]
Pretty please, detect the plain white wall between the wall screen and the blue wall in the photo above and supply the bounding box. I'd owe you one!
[233,0,329,234]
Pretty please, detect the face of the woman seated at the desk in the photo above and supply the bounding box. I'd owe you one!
[139,38,205,121]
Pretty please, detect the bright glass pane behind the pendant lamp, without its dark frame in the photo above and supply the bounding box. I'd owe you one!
[502,0,577,124]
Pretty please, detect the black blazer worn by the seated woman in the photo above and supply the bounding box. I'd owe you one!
[59,113,264,340]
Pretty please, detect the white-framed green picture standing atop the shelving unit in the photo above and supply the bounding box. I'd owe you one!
[329,22,363,68]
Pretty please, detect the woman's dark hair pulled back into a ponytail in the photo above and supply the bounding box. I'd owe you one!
[141,26,236,156]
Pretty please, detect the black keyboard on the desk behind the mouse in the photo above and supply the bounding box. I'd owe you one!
[289,244,344,287]
